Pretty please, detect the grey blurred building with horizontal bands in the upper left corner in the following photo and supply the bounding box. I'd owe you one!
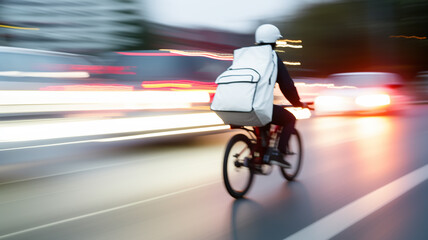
[0,0,142,53]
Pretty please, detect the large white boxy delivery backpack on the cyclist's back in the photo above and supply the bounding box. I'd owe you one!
[211,45,278,126]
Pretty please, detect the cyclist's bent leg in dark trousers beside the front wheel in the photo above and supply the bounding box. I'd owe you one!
[272,105,296,154]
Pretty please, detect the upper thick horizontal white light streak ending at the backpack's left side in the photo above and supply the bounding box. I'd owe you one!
[0,91,210,113]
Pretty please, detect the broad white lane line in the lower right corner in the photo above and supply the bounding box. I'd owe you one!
[284,164,428,240]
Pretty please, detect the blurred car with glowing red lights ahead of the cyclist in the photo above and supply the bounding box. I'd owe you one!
[314,72,406,115]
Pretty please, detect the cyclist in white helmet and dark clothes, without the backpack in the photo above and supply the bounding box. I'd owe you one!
[255,24,307,167]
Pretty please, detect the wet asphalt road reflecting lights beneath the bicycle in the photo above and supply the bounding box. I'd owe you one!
[0,105,428,240]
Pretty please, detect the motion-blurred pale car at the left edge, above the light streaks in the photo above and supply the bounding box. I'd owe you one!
[0,46,99,90]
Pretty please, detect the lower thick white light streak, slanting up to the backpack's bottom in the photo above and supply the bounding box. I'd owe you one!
[0,112,224,142]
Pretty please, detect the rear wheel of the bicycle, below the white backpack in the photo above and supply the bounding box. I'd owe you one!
[223,134,254,198]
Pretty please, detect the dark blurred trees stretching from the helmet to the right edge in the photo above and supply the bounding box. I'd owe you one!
[281,0,428,80]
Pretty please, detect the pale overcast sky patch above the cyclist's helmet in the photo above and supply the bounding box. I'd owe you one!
[143,0,313,33]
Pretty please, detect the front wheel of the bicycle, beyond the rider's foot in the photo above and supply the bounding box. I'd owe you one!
[280,129,303,181]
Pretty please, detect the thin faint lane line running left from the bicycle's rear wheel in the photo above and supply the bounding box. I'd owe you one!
[0,181,220,239]
